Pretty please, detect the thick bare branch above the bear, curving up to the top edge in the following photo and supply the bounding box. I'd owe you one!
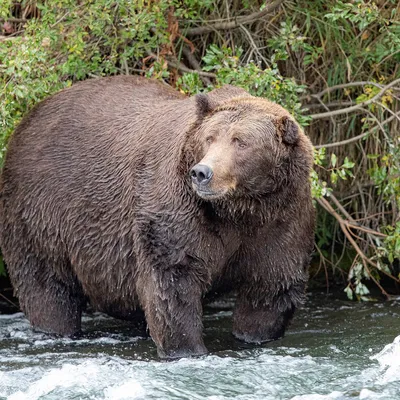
[186,0,284,36]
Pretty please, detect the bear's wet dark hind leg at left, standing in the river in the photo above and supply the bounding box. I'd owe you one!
[9,254,84,337]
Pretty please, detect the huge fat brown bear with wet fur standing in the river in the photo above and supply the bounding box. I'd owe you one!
[0,76,314,358]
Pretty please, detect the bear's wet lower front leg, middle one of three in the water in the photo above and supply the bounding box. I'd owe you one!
[140,267,207,359]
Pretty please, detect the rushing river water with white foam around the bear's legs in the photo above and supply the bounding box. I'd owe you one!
[0,295,400,400]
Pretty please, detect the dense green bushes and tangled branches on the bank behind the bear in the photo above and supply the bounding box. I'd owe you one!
[0,0,400,299]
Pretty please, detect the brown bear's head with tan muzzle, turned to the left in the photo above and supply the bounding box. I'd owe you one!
[189,90,312,200]
